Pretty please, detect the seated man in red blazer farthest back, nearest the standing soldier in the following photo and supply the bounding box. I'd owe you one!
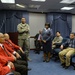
[4,33,27,61]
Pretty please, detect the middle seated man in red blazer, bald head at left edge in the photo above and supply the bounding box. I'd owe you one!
[0,33,29,75]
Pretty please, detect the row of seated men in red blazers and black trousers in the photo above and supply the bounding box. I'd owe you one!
[0,33,30,75]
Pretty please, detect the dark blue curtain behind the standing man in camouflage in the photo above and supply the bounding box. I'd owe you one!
[0,11,29,33]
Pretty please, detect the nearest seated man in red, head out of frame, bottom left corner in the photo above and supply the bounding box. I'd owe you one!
[0,56,21,75]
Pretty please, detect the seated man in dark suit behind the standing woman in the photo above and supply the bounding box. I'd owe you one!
[34,30,42,54]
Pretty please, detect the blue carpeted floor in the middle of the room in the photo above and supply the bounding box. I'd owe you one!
[28,51,75,75]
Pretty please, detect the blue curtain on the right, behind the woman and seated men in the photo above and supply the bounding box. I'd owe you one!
[46,13,72,37]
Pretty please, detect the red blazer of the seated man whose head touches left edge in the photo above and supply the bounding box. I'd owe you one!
[0,43,14,62]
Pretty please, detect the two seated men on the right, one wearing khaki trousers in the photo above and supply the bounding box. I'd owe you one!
[34,31,75,69]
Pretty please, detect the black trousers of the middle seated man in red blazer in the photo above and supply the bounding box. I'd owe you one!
[14,60,28,75]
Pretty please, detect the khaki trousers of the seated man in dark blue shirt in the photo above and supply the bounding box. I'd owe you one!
[59,48,75,66]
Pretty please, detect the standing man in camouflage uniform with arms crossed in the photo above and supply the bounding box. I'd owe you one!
[17,18,31,61]
